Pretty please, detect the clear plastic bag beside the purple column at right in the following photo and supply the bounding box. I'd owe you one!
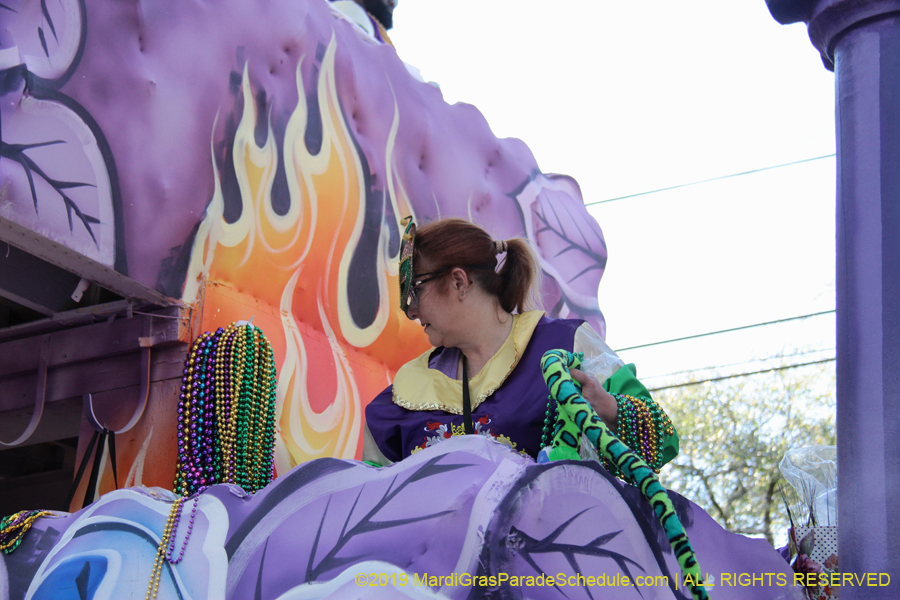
[778,446,837,525]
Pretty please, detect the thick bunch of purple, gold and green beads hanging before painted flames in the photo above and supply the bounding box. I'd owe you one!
[175,323,276,496]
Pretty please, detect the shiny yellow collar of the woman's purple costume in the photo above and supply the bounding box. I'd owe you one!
[393,310,544,415]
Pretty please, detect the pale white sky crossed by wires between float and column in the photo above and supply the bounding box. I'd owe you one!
[390,0,835,388]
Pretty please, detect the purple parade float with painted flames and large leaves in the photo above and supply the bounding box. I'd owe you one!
[0,0,799,600]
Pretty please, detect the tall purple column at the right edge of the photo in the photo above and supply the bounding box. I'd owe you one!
[768,0,900,600]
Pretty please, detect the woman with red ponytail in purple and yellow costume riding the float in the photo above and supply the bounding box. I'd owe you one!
[363,219,678,468]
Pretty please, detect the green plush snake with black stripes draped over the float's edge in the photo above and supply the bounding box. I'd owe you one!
[541,350,709,600]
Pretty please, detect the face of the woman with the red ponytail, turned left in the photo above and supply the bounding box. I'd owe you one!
[409,259,463,348]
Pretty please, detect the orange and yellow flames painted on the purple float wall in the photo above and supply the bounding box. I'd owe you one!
[183,37,428,473]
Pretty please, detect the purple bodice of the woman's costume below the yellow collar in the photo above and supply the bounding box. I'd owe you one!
[366,317,584,462]
